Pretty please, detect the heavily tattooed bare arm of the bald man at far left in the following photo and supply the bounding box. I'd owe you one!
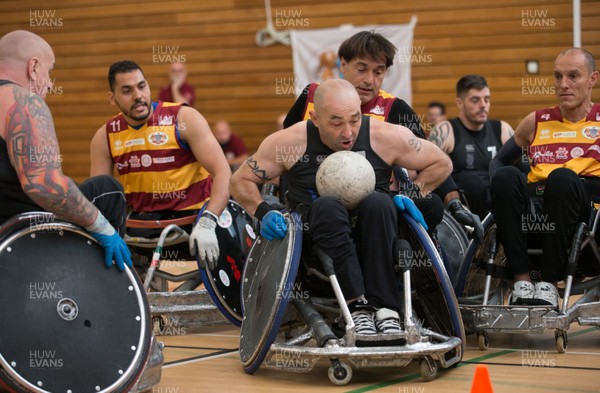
[6,86,96,224]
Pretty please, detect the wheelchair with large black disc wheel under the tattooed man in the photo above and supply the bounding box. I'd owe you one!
[0,212,163,392]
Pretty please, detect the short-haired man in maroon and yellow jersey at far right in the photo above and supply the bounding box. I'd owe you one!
[492,48,600,306]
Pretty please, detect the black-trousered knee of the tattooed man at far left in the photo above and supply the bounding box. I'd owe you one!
[79,175,127,236]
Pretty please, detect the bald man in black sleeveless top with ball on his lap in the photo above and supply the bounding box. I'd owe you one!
[231,79,451,335]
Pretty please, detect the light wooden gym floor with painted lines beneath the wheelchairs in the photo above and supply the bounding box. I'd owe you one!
[152,324,600,393]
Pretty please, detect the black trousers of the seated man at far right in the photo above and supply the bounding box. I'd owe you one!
[491,167,591,282]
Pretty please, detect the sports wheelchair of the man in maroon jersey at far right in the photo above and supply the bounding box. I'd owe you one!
[455,209,600,353]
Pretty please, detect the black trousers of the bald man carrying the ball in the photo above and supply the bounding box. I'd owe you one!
[305,192,401,310]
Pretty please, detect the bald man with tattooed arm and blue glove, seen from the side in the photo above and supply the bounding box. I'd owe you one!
[0,30,131,270]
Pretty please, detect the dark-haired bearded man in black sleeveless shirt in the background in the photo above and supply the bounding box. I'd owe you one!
[429,75,514,218]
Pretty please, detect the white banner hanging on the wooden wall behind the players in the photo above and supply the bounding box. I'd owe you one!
[291,17,416,105]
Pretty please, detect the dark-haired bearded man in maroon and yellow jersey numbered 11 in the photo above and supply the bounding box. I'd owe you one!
[91,60,231,268]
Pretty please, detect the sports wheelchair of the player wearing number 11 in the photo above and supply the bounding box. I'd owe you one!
[125,200,256,335]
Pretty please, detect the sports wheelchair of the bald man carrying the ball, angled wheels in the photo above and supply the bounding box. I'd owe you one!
[219,212,464,385]
